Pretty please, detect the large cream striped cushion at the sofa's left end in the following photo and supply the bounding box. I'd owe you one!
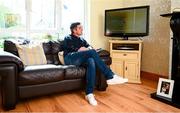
[16,44,47,65]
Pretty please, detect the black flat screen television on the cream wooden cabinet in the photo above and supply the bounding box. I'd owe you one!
[104,6,149,39]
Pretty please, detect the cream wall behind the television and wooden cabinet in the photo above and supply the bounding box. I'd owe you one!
[90,0,171,76]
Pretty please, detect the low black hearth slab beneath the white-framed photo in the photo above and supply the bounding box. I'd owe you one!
[151,93,180,108]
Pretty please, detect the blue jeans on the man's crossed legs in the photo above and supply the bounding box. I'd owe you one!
[64,49,114,94]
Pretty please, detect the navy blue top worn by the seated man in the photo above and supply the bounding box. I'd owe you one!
[63,35,90,57]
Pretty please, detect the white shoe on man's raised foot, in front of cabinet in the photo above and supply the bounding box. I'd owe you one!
[107,75,128,85]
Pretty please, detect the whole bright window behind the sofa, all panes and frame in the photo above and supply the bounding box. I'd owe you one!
[0,0,87,48]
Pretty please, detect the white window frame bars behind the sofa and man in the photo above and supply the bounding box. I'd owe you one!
[0,0,90,42]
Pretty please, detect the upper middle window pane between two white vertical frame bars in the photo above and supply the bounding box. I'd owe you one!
[30,0,56,29]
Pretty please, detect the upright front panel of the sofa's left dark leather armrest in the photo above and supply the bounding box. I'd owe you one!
[0,63,17,110]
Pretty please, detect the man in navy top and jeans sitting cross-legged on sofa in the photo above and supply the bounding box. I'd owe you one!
[64,22,128,106]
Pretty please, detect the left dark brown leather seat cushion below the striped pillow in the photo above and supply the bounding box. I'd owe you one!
[18,64,65,86]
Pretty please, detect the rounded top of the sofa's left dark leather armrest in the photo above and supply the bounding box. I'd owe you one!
[0,51,24,71]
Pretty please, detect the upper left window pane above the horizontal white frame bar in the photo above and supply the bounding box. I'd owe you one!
[0,0,26,29]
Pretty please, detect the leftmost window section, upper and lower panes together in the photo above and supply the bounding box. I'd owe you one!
[0,0,26,48]
